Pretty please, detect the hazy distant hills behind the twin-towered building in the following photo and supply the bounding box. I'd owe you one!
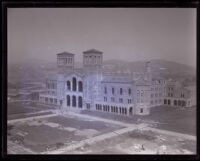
[8,59,196,88]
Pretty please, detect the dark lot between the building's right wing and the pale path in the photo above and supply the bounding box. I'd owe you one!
[82,106,196,135]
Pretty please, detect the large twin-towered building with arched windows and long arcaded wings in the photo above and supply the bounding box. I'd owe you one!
[39,49,196,116]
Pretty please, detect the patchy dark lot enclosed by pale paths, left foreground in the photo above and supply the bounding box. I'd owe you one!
[8,116,122,153]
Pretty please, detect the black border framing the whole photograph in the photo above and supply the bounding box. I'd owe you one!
[1,0,200,160]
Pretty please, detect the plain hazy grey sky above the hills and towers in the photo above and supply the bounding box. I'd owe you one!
[8,8,196,66]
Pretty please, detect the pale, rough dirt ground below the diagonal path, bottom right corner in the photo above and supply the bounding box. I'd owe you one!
[68,130,196,154]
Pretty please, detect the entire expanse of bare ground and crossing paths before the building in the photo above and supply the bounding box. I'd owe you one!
[7,102,196,154]
